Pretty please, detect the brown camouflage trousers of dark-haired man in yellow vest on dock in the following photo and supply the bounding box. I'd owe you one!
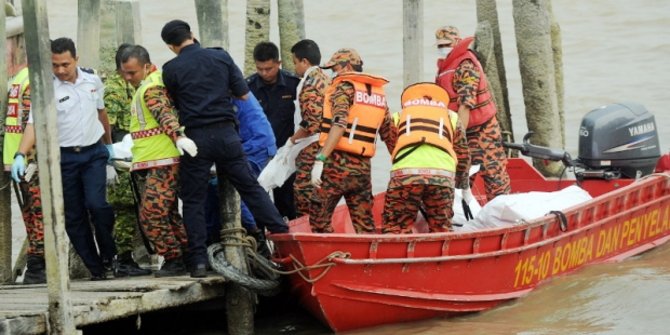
[133,164,187,260]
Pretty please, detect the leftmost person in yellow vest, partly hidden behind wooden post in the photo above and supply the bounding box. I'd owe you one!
[2,67,47,284]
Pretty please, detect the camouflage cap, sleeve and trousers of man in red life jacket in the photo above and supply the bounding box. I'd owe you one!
[435,26,511,200]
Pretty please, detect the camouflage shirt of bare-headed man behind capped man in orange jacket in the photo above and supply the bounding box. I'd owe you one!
[298,68,330,135]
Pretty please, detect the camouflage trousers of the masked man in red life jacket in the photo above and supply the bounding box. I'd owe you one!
[467,116,511,200]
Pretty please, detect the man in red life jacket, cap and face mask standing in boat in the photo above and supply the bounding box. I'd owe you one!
[435,26,511,200]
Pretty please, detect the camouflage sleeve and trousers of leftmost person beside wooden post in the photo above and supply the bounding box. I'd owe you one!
[18,86,44,257]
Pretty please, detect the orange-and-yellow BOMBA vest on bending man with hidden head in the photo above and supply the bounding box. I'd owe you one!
[391,83,458,172]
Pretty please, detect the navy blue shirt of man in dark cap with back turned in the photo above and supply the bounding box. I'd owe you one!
[163,43,249,128]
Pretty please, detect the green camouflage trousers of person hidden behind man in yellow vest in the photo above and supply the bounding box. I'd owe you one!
[107,170,137,255]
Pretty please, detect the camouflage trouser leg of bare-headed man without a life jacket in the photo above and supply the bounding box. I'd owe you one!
[293,142,319,217]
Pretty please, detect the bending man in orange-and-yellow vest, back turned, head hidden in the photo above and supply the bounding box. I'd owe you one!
[382,83,470,234]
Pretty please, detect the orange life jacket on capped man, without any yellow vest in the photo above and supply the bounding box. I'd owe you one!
[319,72,388,157]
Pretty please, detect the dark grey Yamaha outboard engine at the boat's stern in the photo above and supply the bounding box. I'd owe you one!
[577,102,661,178]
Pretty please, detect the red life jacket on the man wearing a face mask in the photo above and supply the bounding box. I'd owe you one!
[435,37,496,128]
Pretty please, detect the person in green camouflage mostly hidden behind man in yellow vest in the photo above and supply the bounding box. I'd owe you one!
[104,43,151,278]
